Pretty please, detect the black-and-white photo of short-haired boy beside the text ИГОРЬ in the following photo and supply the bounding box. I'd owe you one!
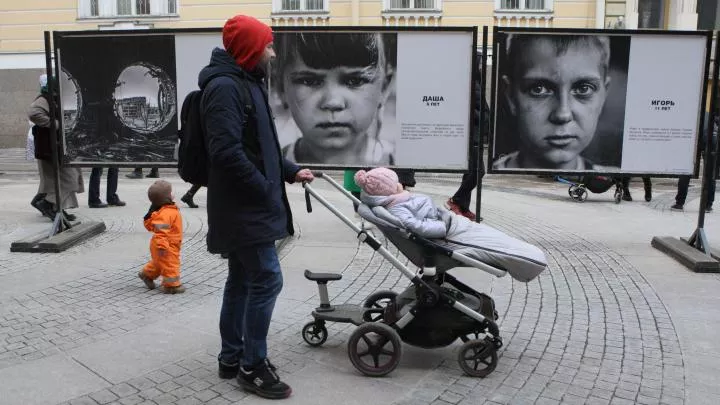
[492,33,630,172]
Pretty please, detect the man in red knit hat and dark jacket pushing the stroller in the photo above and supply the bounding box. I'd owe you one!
[198,15,313,399]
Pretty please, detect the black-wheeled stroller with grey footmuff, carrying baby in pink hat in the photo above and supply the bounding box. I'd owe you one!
[302,173,546,377]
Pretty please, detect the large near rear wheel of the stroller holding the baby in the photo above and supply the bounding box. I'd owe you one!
[348,322,402,377]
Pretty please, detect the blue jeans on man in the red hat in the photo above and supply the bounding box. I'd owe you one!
[218,243,283,368]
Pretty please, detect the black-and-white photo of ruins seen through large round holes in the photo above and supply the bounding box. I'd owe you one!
[60,35,178,163]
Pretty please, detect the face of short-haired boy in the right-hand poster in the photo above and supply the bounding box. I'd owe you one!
[504,39,610,169]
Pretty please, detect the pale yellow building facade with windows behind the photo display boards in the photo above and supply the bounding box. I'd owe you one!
[0,0,697,147]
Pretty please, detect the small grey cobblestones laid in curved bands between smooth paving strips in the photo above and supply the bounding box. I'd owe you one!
[0,181,685,405]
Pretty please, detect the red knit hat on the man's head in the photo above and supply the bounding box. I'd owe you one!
[223,15,273,71]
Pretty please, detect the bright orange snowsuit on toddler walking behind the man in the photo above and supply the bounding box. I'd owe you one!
[143,203,182,287]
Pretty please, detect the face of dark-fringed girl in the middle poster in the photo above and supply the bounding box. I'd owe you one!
[283,57,385,149]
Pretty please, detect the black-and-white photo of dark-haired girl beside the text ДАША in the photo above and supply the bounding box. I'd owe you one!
[270,32,397,166]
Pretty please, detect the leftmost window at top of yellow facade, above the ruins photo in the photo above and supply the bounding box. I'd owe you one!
[78,0,178,18]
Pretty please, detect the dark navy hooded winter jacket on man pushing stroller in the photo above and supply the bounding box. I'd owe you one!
[198,48,299,253]
